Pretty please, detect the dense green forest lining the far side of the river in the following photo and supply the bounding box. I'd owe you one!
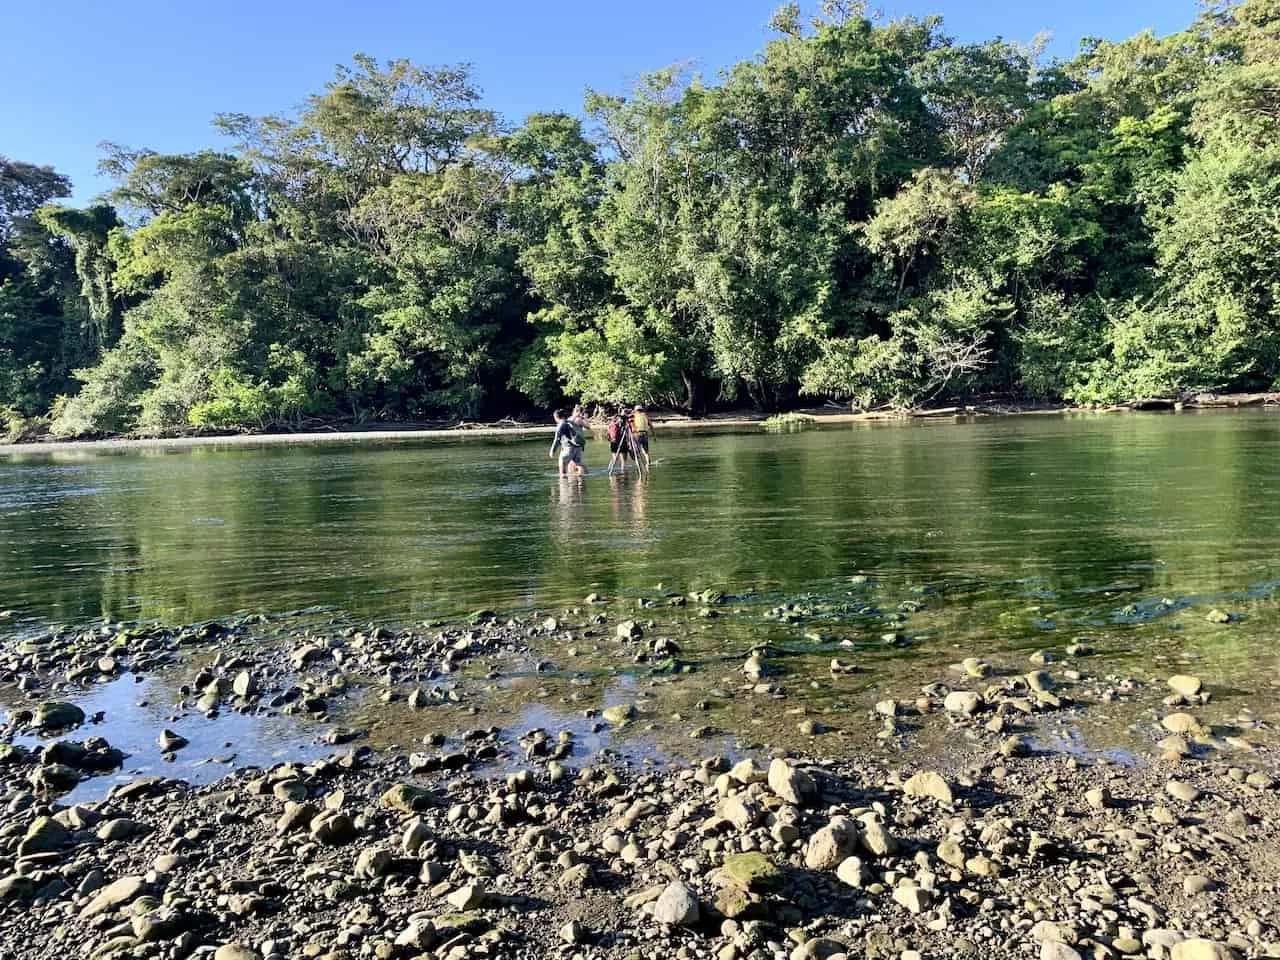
[0,0,1280,436]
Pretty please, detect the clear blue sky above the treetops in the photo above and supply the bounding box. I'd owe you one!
[0,0,1198,201]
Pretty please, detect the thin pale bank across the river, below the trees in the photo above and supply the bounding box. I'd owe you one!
[0,393,1280,456]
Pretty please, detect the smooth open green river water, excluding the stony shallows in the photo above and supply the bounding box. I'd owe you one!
[0,411,1280,626]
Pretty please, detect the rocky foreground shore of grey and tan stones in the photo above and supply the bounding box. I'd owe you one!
[0,609,1280,960]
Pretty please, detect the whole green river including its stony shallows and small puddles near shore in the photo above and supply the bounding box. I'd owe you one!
[0,410,1280,798]
